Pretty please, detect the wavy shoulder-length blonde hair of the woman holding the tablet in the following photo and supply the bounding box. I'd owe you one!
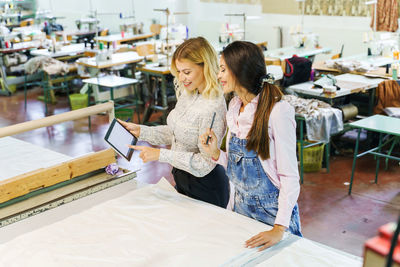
[171,37,222,98]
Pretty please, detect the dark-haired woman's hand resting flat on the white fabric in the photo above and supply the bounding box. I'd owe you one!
[245,224,286,251]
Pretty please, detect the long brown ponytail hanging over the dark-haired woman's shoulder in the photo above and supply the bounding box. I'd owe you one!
[246,81,283,160]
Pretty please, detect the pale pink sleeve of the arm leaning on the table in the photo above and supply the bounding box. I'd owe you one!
[271,102,300,227]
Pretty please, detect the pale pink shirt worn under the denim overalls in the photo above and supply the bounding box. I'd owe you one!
[217,96,300,227]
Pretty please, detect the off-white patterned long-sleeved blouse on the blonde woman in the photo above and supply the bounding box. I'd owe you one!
[139,91,226,177]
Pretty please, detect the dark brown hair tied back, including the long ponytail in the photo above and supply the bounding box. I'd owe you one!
[222,41,282,160]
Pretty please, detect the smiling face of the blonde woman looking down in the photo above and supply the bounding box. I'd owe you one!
[175,59,206,93]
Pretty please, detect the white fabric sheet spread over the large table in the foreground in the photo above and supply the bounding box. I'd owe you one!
[0,179,361,267]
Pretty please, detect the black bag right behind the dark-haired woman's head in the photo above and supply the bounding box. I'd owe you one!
[283,55,312,87]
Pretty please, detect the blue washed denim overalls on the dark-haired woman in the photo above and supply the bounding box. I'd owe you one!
[227,133,302,236]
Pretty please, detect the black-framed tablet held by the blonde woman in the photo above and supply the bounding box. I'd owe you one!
[104,119,137,161]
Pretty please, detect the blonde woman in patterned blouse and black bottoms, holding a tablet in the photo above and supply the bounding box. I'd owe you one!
[120,37,229,208]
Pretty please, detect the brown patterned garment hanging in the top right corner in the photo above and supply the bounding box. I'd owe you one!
[371,0,399,32]
